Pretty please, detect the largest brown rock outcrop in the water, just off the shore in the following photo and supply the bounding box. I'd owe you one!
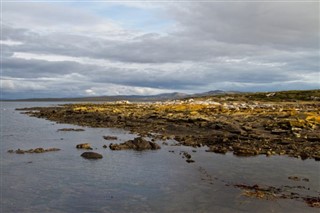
[109,137,160,151]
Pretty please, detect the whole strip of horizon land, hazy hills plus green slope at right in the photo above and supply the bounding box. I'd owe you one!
[5,90,320,102]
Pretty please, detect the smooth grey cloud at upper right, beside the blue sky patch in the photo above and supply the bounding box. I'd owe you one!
[171,2,319,49]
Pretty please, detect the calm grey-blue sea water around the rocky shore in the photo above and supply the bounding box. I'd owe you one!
[0,102,320,213]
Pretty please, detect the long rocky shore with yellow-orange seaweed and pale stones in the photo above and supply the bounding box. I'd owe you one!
[20,95,320,160]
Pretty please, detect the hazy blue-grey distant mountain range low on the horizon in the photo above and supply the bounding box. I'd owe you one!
[4,90,240,102]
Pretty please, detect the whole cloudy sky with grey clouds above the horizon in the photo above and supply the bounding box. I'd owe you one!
[0,0,320,99]
